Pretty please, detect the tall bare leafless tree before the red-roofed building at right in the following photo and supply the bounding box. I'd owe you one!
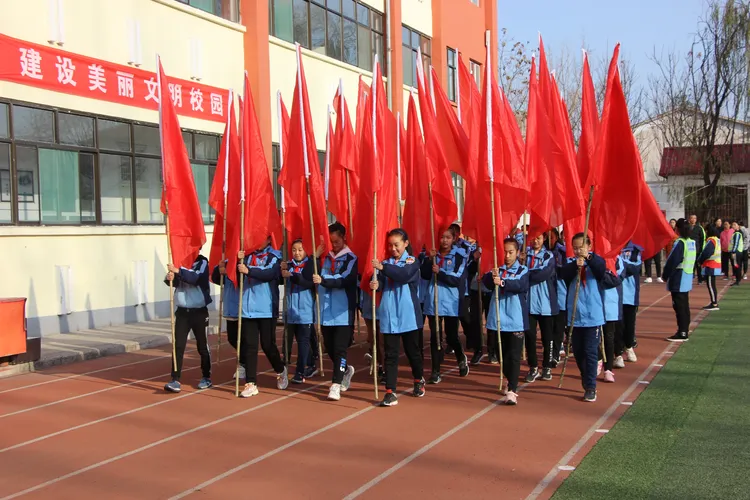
[649,0,750,220]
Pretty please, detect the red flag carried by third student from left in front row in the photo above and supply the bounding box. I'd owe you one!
[279,45,330,253]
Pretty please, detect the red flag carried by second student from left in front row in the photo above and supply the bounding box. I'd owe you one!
[240,72,283,254]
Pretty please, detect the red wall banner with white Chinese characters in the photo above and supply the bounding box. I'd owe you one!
[0,34,229,122]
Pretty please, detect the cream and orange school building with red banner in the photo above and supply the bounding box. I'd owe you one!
[0,0,497,336]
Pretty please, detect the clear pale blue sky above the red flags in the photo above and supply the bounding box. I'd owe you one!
[497,0,705,86]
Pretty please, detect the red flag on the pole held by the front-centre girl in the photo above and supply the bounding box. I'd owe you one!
[352,59,398,291]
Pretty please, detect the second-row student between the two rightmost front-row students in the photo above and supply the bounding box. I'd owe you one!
[526,234,560,383]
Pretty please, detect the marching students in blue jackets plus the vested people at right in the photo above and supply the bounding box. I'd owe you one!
[165,220,715,406]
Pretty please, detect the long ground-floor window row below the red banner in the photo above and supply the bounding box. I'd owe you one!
[0,102,220,225]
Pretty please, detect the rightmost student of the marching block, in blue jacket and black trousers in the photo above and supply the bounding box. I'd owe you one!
[613,241,643,368]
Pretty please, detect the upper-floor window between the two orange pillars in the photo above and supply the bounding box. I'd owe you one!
[269,0,384,71]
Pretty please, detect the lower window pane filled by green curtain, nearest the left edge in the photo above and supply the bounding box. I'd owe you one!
[39,148,81,224]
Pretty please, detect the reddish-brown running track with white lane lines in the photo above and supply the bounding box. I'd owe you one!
[0,284,707,500]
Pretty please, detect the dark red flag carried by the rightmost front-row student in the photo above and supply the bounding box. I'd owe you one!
[590,44,643,258]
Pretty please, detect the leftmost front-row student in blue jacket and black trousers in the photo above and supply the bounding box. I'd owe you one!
[164,255,211,392]
